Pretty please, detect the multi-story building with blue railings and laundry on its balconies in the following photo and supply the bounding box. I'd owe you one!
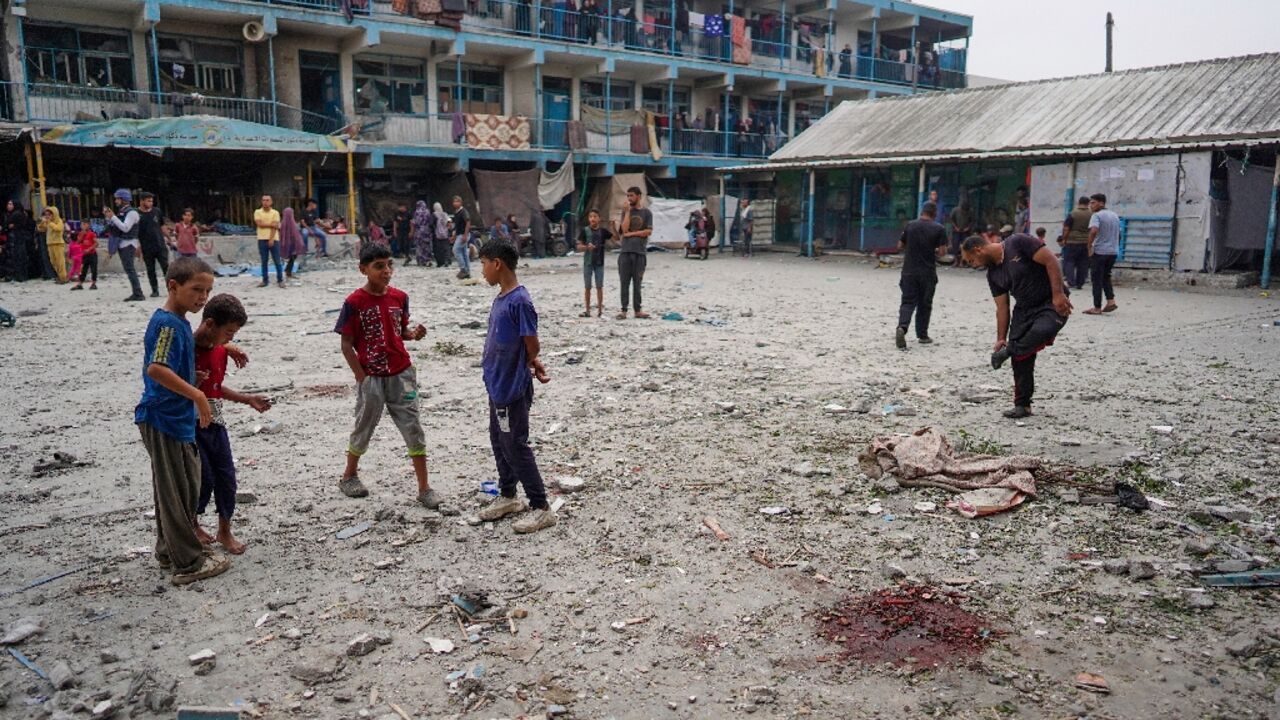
[0,0,973,222]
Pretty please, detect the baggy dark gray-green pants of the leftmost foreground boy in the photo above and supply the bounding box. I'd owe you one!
[138,423,205,573]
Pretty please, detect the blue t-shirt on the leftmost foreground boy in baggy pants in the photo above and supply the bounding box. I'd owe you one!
[133,307,196,442]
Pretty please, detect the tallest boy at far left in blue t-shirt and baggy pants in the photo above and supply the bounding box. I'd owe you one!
[133,258,230,585]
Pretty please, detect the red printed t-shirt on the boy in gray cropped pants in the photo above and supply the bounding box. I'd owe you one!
[333,287,413,378]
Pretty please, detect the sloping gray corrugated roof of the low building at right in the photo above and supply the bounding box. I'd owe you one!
[732,53,1280,170]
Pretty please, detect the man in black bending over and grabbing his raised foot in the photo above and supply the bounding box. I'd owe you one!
[961,233,1071,419]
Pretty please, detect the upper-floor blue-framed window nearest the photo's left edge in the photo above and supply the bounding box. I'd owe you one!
[23,23,134,90]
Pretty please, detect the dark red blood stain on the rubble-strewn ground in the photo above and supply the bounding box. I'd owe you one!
[818,584,998,670]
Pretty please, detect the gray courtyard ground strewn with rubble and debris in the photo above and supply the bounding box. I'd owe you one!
[0,245,1280,719]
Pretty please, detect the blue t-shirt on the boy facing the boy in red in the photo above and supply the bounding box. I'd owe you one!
[481,286,538,406]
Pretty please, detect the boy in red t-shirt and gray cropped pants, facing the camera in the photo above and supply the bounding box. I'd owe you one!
[333,242,440,510]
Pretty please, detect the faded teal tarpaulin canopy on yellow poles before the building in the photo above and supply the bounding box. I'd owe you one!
[41,115,347,152]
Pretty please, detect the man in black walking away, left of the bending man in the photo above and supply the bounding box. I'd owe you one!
[893,202,947,350]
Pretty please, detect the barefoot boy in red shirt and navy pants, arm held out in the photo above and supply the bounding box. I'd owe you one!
[188,295,271,555]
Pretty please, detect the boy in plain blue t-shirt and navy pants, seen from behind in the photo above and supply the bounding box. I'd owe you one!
[480,241,556,533]
